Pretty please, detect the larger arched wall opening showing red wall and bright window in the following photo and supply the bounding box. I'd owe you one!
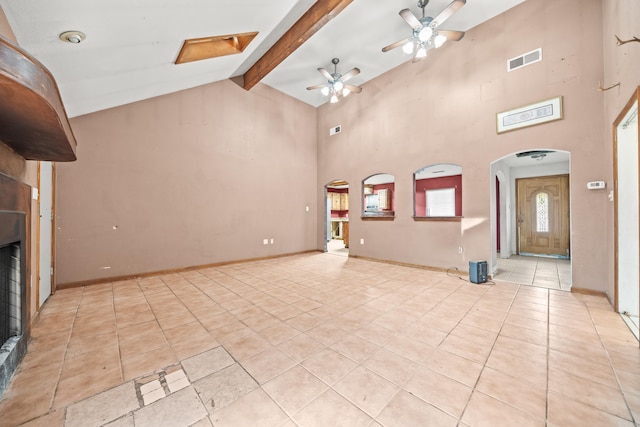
[413,163,462,219]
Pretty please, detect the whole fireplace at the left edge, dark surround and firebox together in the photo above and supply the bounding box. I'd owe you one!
[0,174,31,395]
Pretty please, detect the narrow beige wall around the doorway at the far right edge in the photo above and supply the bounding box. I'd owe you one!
[603,0,640,297]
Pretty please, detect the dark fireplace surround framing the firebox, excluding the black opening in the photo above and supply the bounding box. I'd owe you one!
[0,174,31,396]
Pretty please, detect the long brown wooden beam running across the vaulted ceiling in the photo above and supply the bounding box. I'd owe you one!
[242,0,353,90]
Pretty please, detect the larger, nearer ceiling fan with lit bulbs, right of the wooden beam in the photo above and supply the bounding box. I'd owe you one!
[382,0,467,62]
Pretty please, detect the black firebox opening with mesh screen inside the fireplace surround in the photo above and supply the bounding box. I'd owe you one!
[0,242,22,345]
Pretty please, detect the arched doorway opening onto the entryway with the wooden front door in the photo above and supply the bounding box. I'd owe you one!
[490,148,572,290]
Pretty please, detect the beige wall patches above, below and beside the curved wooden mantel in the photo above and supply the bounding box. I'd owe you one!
[0,7,38,316]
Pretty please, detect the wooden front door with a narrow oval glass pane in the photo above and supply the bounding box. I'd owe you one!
[516,175,570,258]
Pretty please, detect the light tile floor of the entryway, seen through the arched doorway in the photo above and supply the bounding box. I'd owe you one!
[493,255,571,291]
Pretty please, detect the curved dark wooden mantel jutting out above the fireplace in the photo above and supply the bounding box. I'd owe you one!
[0,37,76,162]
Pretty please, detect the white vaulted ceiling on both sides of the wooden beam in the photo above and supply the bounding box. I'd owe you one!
[0,0,524,117]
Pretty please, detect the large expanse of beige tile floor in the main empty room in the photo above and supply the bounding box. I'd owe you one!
[0,253,640,427]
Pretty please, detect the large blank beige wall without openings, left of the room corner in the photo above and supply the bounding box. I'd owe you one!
[57,81,317,283]
